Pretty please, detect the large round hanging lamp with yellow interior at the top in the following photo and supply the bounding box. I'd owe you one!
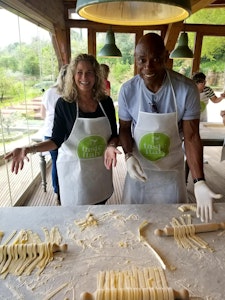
[76,0,191,26]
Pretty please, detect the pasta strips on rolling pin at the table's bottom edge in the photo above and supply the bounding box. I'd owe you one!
[80,267,189,300]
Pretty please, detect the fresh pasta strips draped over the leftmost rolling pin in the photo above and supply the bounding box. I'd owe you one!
[0,227,67,279]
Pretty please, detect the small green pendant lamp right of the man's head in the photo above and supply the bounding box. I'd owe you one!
[170,32,194,59]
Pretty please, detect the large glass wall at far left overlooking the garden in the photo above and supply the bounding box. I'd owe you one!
[0,8,58,206]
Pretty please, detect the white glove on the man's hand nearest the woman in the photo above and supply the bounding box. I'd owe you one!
[126,155,147,182]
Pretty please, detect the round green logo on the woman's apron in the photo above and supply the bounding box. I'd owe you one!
[77,135,106,159]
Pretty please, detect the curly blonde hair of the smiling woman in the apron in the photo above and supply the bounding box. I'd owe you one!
[62,54,105,102]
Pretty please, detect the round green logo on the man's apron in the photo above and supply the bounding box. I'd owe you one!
[139,132,170,161]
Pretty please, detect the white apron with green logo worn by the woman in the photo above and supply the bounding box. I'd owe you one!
[57,103,113,206]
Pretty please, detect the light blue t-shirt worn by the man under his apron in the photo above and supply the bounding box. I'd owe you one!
[118,70,200,133]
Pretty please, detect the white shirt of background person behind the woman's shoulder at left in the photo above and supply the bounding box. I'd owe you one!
[42,87,60,137]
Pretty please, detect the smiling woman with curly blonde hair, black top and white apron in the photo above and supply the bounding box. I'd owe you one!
[5,54,120,206]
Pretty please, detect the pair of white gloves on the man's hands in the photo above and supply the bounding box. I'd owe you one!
[126,155,222,223]
